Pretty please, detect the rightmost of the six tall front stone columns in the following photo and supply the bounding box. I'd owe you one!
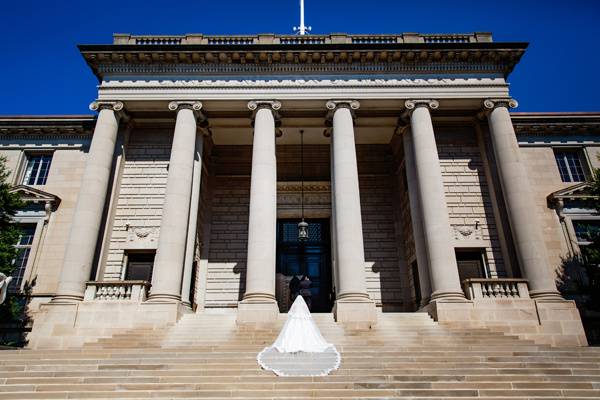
[483,99,561,299]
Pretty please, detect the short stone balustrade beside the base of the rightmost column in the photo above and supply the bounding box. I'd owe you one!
[463,278,529,300]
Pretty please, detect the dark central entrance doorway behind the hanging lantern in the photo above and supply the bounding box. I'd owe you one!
[276,219,333,312]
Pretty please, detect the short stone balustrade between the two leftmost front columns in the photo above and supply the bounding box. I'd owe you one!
[84,281,150,303]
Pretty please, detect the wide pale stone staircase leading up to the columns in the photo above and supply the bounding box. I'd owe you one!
[0,313,600,399]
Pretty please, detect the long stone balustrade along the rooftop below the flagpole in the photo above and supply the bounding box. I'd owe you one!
[113,32,492,46]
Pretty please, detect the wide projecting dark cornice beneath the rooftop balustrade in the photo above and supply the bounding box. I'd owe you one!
[79,43,527,80]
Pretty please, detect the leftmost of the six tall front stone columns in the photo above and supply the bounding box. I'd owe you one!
[52,101,123,303]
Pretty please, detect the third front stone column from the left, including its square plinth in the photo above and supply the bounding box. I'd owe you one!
[237,101,281,324]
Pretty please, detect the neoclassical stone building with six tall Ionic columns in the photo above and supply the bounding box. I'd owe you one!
[0,33,600,347]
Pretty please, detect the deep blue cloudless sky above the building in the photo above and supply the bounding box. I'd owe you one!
[0,0,600,115]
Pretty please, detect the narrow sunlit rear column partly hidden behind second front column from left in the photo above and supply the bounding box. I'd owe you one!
[181,135,204,306]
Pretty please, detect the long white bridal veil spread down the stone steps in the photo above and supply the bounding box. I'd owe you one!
[257,296,341,376]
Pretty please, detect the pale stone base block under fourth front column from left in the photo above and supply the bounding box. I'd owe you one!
[333,297,377,329]
